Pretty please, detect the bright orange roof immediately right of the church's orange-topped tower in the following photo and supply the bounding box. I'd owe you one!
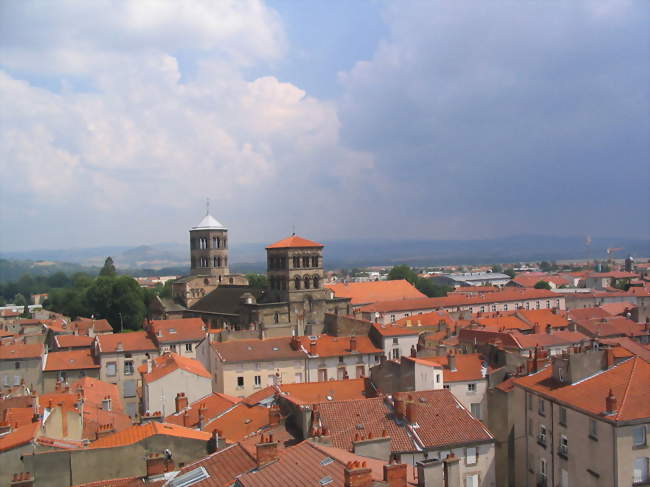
[325,279,426,305]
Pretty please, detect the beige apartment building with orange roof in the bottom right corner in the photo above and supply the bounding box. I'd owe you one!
[512,348,650,487]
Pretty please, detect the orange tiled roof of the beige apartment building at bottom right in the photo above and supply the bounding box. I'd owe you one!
[515,357,650,421]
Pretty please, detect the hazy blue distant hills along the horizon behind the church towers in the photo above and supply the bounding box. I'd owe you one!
[0,235,650,280]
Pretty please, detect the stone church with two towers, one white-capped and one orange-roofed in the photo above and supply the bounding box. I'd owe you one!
[151,211,351,338]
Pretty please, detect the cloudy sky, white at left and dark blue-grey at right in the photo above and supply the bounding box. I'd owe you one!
[0,0,650,251]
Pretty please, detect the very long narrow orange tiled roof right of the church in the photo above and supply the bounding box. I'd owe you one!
[361,288,564,313]
